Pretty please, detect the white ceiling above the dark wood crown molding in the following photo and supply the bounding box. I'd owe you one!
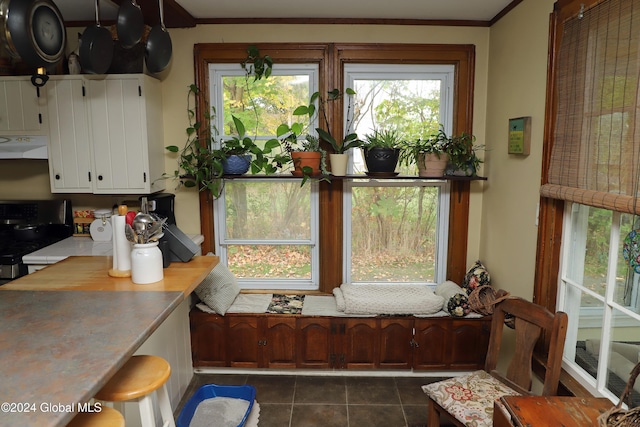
[53,0,522,28]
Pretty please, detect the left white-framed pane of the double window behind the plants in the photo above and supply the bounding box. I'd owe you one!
[209,64,319,290]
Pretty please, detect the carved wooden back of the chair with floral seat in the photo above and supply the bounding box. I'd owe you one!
[485,298,567,396]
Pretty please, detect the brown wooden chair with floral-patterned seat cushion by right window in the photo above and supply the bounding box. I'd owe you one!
[422,298,567,427]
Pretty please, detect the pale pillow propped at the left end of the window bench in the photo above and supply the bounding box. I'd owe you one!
[195,263,240,316]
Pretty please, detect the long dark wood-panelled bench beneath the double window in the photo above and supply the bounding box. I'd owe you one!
[190,294,491,371]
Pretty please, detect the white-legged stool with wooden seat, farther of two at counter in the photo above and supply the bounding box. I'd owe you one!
[95,355,176,427]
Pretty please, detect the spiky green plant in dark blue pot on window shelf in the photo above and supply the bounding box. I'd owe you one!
[363,129,403,176]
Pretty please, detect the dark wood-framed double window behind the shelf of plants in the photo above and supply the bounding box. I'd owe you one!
[194,43,475,294]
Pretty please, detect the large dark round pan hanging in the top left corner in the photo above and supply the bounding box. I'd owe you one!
[0,0,67,68]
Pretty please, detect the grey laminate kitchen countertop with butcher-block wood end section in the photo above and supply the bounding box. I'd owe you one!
[0,256,218,427]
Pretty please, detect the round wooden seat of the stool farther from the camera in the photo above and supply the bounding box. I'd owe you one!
[95,355,171,402]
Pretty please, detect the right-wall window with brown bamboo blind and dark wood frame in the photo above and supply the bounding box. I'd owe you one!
[535,0,640,399]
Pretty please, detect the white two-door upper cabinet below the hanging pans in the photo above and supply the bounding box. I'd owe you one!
[47,74,165,194]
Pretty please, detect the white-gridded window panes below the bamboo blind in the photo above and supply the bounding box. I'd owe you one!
[558,203,640,399]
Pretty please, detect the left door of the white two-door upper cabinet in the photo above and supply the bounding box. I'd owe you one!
[45,76,92,193]
